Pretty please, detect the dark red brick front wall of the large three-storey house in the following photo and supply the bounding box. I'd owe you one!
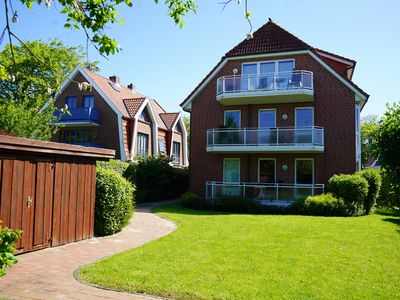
[190,54,356,195]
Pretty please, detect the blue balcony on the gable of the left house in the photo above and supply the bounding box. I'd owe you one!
[53,107,100,127]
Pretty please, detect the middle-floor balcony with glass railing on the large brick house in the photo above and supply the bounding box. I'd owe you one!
[207,126,325,153]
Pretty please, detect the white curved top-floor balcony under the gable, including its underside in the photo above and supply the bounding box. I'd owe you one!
[217,70,314,105]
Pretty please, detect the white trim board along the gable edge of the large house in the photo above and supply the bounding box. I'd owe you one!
[181,50,368,111]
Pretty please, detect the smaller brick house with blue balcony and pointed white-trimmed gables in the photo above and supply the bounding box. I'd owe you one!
[53,66,188,166]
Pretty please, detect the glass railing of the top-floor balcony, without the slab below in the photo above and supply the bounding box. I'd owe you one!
[217,70,313,96]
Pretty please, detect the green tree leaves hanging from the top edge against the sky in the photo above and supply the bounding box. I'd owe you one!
[20,0,196,55]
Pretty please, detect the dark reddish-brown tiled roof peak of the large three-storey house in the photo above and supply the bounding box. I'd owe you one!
[225,19,313,57]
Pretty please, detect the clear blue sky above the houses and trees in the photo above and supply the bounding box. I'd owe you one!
[7,0,400,116]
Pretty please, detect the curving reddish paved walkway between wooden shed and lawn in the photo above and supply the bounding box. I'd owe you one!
[0,203,176,299]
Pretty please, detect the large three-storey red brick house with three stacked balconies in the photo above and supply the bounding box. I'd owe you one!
[181,20,369,201]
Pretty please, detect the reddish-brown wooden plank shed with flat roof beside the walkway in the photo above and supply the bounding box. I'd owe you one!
[0,135,114,253]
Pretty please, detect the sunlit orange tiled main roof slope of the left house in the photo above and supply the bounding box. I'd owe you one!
[84,69,146,118]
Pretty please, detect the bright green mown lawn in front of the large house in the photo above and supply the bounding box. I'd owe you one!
[80,205,400,299]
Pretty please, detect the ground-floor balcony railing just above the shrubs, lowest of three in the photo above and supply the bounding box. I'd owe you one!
[206,181,325,205]
